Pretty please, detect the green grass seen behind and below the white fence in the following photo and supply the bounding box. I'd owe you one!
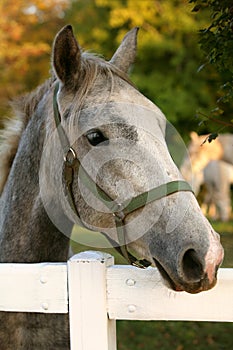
[73,221,233,350]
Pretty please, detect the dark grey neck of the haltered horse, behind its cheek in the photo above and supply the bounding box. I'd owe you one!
[0,106,69,262]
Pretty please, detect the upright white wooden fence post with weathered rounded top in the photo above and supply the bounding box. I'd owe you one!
[68,251,116,350]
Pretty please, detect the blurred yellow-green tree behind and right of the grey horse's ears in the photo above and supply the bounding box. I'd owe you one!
[65,0,228,134]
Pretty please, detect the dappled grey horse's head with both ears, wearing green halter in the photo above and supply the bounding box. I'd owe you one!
[43,26,223,293]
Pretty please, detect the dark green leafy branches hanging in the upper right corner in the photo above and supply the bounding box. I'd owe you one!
[190,0,233,126]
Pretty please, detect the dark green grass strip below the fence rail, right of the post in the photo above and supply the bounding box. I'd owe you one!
[117,321,233,350]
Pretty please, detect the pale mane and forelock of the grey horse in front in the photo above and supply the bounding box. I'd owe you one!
[0,52,133,194]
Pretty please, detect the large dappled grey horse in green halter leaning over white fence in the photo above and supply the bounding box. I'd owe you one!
[0,25,223,350]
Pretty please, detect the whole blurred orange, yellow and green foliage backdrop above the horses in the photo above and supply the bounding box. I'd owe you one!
[0,0,233,139]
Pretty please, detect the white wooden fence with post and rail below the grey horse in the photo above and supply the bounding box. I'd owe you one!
[0,251,233,350]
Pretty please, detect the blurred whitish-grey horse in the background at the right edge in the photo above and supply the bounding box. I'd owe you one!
[189,160,233,221]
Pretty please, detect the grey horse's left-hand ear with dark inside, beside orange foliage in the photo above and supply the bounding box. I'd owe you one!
[52,25,81,87]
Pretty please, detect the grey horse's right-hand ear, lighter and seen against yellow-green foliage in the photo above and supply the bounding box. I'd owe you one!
[110,27,139,73]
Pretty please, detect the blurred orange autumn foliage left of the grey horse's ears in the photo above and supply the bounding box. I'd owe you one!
[0,0,68,121]
